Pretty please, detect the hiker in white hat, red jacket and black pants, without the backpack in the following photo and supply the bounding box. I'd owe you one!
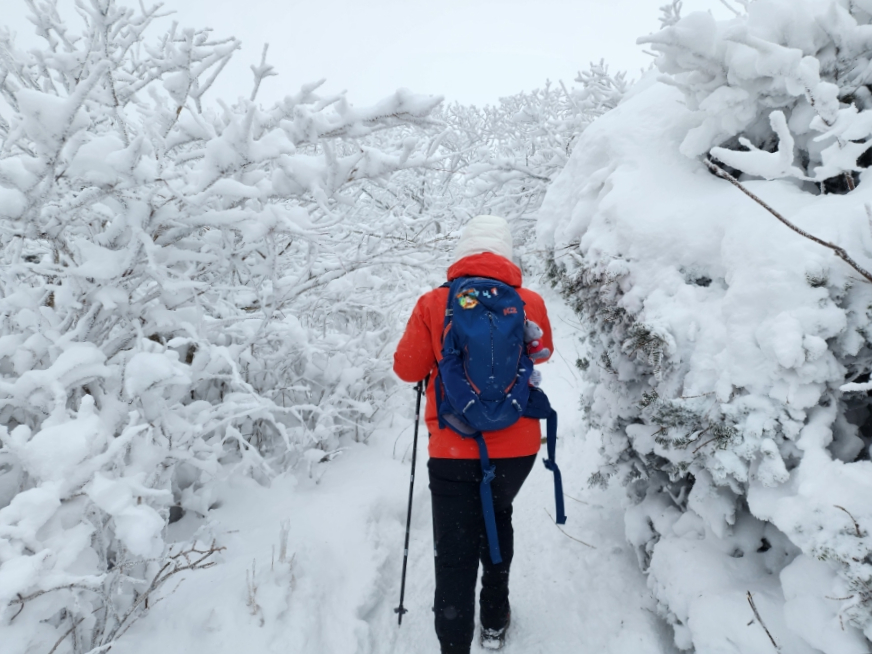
[394,216,554,654]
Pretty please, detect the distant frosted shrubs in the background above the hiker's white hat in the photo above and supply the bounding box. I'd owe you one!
[358,62,629,265]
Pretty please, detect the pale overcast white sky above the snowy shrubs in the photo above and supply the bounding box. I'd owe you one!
[0,0,729,104]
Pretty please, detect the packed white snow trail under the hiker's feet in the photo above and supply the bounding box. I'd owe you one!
[114,286,675,654]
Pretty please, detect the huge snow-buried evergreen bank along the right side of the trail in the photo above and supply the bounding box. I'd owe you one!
[539,0,872,654]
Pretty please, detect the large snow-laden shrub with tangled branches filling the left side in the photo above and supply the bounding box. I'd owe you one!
[0,0,439,653]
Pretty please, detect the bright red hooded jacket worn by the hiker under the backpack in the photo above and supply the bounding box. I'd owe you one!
[394,252,554,459]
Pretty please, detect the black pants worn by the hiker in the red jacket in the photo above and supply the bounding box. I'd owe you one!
[427,455,536,654]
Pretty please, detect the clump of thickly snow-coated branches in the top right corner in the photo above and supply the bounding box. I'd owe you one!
[640,0,872,191]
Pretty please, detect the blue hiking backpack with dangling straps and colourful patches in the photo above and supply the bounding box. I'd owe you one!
[436,277,566,564]
